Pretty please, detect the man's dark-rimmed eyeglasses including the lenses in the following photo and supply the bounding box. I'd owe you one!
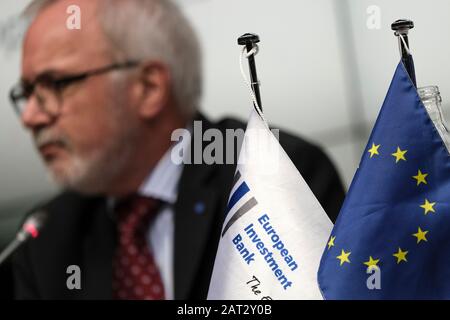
[9,61,139,117]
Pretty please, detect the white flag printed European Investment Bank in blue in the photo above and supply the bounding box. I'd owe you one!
[208,111,332,300]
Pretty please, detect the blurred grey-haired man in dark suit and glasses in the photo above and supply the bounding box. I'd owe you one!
[11,0,344,299]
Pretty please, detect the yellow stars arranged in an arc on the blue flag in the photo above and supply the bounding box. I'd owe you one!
[327,143,436,268]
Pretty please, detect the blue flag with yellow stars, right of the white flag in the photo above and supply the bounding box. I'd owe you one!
[318,63,450,299]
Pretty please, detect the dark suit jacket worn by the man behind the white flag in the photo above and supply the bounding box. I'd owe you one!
[13,114,344,299]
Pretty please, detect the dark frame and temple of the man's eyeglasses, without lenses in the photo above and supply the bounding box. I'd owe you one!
[9,60,140,117]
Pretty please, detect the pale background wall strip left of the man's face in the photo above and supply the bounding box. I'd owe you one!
[0,0,52,203]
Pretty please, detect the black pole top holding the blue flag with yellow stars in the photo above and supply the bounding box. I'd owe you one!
[391,19,417,87]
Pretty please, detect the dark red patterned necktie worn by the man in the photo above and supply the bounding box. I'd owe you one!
[113,195,164,300]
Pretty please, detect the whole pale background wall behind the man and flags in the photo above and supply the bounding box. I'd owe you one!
[0,0,450,204]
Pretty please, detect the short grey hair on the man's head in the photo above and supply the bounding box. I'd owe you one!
[24,0,202,115]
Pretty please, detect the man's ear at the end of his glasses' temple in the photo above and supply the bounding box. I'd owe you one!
[134,62,172,119]
